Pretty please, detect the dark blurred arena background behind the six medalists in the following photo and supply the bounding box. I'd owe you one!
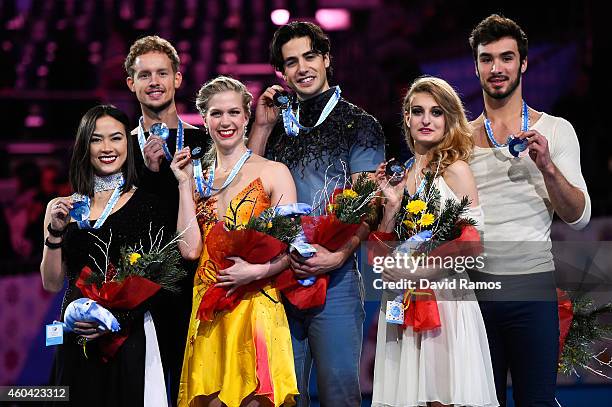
[0,0,612,406]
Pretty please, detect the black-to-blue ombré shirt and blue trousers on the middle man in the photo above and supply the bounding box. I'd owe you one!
[266,88,385,406]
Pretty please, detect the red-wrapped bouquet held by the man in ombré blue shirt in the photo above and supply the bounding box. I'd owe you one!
[276,174,378,309]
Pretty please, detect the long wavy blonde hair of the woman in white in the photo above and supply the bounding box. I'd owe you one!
[402,76,474,175]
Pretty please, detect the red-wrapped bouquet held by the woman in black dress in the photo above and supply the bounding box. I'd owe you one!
[74,229,187,360]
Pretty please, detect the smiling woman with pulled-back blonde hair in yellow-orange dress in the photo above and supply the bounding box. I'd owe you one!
[178,76,298,407]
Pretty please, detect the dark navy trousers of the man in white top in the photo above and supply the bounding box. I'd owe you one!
[477,273,559,407]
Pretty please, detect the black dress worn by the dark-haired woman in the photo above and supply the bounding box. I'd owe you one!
[52,189,176,407]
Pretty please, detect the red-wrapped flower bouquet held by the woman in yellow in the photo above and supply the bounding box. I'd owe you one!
[197,201,299,321]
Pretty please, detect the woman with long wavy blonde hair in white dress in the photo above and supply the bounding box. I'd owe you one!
[372,77,498,407]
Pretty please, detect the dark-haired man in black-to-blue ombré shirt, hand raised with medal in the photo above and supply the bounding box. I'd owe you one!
[249,22,384,407]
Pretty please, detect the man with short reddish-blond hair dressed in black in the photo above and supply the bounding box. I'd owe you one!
[124,36,206,404]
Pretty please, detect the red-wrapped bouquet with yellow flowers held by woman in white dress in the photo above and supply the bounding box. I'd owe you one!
[368,172,482,331]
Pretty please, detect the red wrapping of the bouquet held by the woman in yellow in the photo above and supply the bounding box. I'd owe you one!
[197,222,287,321]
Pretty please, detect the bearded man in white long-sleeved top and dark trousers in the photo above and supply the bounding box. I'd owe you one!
[469,15,591,406]
